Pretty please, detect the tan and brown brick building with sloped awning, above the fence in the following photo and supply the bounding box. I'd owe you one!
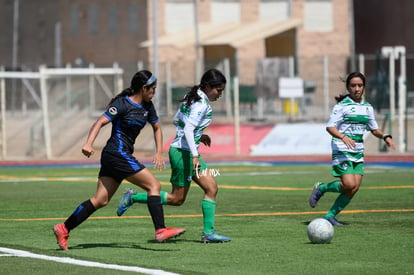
[0,0,350,94]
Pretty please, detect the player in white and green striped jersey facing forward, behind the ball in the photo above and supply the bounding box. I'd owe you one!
[309,72,395,226]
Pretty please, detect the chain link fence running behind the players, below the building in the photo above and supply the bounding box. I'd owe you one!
[1,54,414,159]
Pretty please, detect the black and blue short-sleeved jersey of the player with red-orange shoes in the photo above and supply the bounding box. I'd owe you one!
[103,96,159,154]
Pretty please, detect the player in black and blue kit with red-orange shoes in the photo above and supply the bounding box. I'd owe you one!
[53,70,185,250]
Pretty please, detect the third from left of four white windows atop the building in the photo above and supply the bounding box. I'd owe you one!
[259,0,290,21]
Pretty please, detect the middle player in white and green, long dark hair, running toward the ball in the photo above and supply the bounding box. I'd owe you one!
[117,69,230,243]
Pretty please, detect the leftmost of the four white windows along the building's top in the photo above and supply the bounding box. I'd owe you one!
[165,0,194,33]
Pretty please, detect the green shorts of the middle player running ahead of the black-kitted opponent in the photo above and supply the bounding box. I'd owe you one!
[168,147,208,187]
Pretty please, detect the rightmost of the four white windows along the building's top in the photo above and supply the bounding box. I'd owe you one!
[304,0,333,32]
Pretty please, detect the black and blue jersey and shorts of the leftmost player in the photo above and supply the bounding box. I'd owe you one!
[99,96,159,183]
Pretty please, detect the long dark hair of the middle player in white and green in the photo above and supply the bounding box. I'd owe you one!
[179,69,227,107]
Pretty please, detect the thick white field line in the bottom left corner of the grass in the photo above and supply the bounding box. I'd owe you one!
[0,247,178,275]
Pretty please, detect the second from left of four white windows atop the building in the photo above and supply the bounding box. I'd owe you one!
[211,0,240,24]
